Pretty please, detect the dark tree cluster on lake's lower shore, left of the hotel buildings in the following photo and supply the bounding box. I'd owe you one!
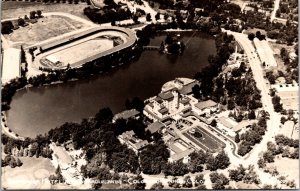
[48,108,145,178]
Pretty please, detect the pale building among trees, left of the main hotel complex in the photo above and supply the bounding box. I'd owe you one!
[118,130,149,153]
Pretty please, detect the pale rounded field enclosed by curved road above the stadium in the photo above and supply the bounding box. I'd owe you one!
[4,15,87,44]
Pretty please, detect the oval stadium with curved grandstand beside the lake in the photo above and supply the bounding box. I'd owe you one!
[32,26,136,69]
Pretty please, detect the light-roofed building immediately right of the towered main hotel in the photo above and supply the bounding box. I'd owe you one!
[192,100,218,116]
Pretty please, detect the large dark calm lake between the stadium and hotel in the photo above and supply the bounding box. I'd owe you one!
[8,32,216,137]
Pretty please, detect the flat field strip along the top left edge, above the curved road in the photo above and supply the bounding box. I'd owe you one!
[1,1,89,20]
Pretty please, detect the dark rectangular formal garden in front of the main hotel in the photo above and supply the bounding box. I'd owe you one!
[183,127,225,152]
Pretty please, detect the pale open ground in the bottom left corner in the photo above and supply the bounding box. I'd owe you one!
[2,157,55,189]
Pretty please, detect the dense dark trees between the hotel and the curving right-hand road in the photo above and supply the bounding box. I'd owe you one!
[209,62,262,112]
